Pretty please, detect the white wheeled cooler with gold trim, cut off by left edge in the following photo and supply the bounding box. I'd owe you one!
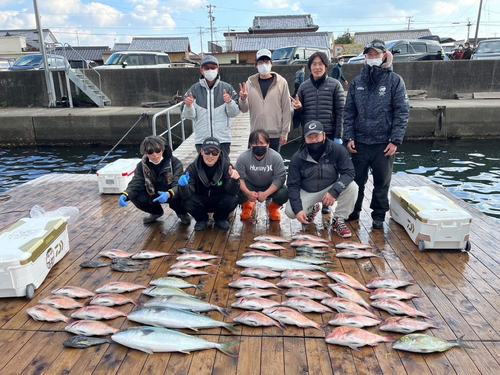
[0,217,69,298]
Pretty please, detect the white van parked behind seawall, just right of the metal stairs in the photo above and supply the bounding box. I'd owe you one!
[95,51,171,70]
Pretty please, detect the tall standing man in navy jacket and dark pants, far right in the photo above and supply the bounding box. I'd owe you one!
[344,40,410,229]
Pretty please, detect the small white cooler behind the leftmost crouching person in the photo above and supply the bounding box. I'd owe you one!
[97,158,141,194]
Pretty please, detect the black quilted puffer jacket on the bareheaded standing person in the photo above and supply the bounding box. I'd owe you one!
[294,75,345,138]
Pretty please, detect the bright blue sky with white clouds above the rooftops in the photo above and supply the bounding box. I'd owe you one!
[0,0,500,53]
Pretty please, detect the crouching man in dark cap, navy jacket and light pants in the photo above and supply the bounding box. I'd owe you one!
[285,121,358,238]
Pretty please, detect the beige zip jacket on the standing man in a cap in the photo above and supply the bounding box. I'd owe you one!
[239,72,292,138]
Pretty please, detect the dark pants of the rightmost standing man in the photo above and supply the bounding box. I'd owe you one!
[351,142,395,221]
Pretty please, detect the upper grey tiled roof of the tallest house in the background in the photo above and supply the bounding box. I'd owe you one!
[248,14,319,34]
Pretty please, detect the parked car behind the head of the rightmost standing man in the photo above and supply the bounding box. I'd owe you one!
[349,39,449,64]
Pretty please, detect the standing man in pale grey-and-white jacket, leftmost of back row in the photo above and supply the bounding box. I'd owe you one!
[182,55,240,160]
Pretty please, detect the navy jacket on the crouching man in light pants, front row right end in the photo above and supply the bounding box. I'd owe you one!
[287,139,355,214]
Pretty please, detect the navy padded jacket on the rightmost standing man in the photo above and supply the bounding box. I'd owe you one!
[344,66,410,146]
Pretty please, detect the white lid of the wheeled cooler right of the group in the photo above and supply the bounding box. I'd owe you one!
[391,186,472,222]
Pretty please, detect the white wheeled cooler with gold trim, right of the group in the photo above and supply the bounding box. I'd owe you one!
[391,186,472,251]
